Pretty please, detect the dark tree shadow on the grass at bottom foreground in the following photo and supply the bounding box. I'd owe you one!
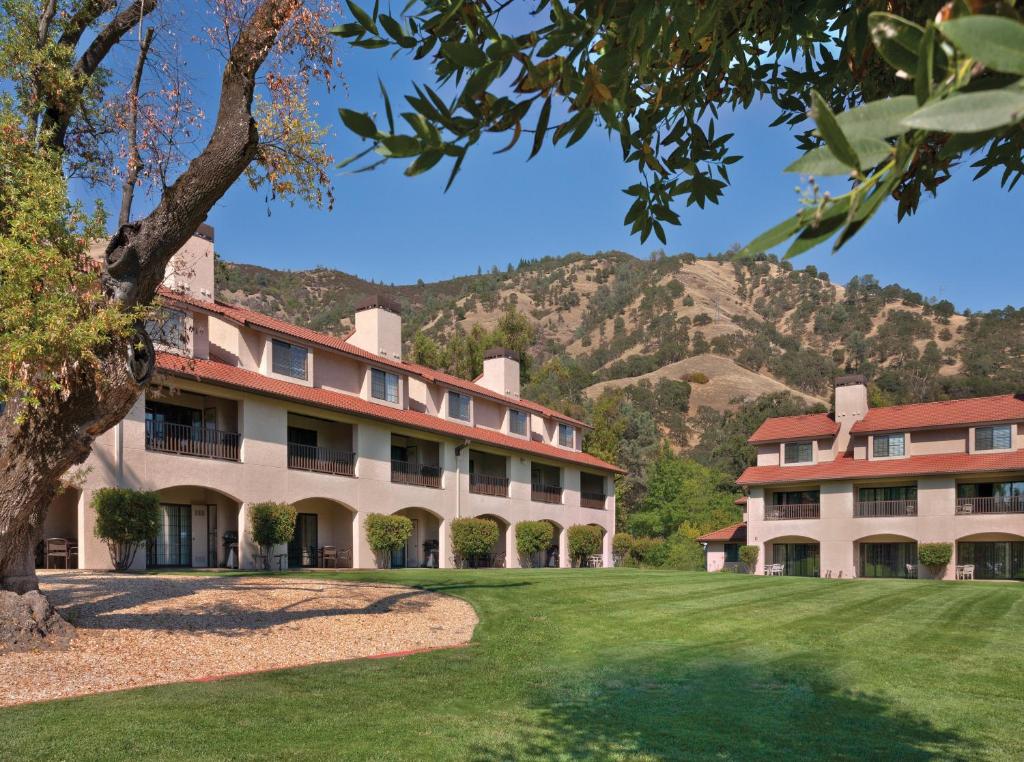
[470,654,970,762]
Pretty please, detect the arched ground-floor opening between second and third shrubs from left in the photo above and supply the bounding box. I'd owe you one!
[288,498,355,568]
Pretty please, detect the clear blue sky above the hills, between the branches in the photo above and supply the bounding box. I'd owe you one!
[92,18,1024,309]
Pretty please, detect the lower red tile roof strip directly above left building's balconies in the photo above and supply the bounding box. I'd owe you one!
[157,352,625,473]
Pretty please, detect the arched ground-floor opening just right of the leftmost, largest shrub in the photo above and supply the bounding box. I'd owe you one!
[145,486,242,568]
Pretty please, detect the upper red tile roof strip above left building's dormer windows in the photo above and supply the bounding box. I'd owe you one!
[160,289,592,428]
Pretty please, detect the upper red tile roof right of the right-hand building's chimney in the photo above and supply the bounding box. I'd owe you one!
[851,394,1024,434]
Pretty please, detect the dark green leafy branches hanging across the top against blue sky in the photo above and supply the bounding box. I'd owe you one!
[327,0,1007,242]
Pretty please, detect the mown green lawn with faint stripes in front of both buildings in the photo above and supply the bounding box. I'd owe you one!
[0,569,1024,760]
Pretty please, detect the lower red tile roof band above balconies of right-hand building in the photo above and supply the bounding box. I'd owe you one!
[736,450,1024,484]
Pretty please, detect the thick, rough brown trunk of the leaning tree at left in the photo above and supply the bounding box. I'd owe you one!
[0,0,302,606]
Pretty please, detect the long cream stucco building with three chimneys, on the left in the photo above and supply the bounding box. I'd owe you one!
[40,226,618,568]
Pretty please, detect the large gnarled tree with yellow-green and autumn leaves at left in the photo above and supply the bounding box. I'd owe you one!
[0,0,336,592]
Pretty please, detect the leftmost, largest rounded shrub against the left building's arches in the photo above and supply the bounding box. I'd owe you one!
[92,486,160,572]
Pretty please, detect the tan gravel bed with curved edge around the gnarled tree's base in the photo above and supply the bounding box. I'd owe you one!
[0,572,477,707]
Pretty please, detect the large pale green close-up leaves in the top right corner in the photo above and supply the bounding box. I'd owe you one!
[745,0,1024,257]
